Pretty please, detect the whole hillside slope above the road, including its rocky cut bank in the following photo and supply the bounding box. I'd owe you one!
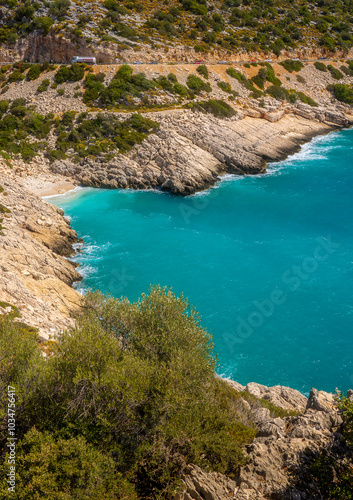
[0,0,353,62]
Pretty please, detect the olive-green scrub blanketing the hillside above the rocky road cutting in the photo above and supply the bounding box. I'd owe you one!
[0,0,353,55]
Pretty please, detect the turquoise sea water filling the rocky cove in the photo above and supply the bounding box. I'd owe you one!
[50,130,353,393]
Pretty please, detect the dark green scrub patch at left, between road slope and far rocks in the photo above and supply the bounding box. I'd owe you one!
[0,89,159,162]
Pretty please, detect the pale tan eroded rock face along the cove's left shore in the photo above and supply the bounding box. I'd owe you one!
[0,174,82,338]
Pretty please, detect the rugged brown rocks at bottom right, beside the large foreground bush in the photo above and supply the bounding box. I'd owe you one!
[175,381,353,500]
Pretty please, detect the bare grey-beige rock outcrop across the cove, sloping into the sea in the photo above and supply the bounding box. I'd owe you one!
[51,110,346,195]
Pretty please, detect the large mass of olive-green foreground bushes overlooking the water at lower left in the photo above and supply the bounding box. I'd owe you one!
[0,287,255,500]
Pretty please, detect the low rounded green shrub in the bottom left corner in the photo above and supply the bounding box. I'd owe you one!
[0,428,133,500]
